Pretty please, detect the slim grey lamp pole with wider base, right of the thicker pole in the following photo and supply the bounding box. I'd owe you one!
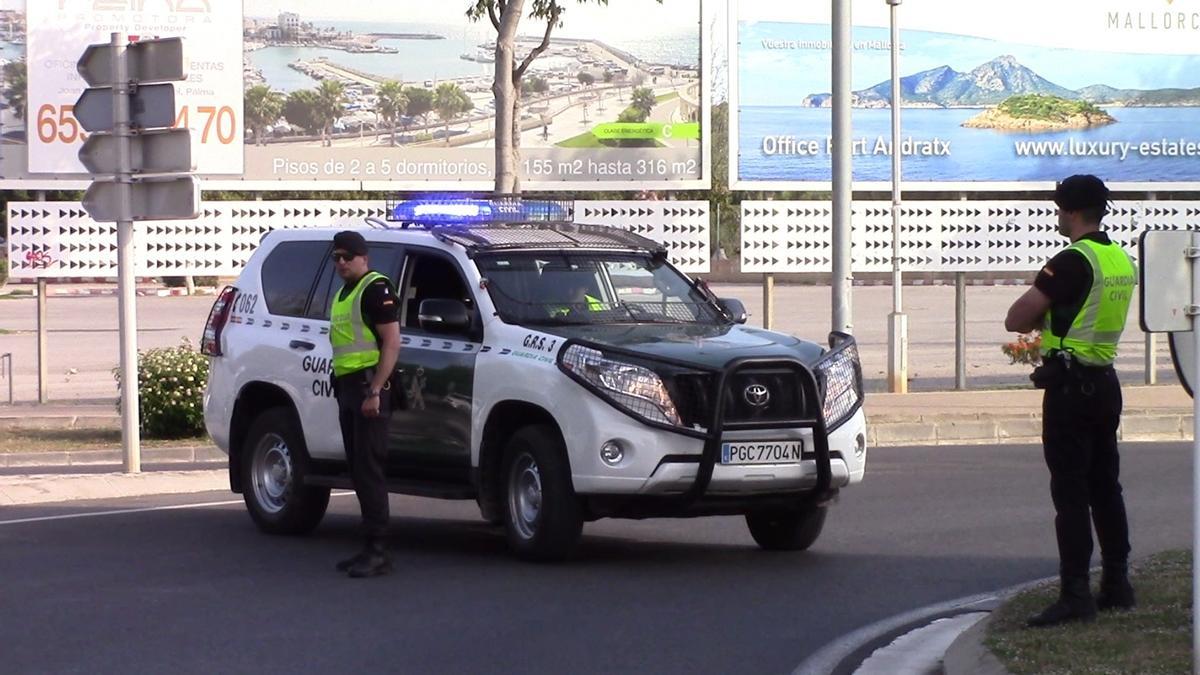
[887,0,908,394]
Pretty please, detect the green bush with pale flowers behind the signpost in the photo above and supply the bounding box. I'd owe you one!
[113,339,209,438]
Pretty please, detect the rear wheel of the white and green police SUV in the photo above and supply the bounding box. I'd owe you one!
[241,407,329,534]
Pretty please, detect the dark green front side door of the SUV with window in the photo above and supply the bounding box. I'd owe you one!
[389,246,480,483]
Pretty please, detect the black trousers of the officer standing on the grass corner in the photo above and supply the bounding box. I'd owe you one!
[1042,366,1129,578]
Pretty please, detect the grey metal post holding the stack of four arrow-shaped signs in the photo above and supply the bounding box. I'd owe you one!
[112,32,142,473]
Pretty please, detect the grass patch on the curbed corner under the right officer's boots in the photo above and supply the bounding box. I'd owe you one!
[984,550,1192,675]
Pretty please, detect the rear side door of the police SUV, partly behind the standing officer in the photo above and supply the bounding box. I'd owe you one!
[302,241,402,460]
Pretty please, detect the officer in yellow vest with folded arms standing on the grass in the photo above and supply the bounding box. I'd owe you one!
[1004,175,1136,627]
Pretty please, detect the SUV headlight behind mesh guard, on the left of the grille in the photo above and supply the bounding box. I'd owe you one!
[562,345,680,426]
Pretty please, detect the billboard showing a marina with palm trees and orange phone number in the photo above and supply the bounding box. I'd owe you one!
[0,0,709,190]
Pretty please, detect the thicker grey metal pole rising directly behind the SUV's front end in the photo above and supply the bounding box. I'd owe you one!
[832,0,854,333]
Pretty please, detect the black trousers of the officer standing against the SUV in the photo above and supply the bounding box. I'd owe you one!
[334,369,391,539]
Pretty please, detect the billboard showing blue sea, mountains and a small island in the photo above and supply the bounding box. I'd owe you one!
[730,0,1200,190]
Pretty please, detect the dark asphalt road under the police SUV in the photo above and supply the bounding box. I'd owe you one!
[0,443,1192,674]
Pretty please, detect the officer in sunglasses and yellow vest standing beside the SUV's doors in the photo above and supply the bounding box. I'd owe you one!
[329,231,400,578]
